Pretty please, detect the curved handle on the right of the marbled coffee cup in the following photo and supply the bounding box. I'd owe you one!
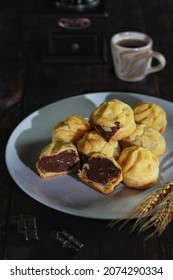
[147,51,166,74]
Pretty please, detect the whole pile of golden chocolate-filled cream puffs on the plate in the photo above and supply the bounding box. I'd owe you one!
[36,99,167,194]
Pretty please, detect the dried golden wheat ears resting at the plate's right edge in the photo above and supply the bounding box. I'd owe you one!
[110,182,173,237]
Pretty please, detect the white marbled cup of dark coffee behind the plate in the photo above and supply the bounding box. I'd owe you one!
[111,31,166,82]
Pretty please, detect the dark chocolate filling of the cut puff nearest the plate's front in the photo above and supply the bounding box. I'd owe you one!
[85,157,120,185]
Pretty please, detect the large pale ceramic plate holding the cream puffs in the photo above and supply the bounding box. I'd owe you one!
[5,92,173,219]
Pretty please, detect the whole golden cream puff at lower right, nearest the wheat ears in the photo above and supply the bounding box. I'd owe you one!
[118,146,159,189]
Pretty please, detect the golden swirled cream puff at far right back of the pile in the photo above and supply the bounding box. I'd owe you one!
[134,102,167,134]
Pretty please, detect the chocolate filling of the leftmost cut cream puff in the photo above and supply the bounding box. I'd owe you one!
[39,150,77,172]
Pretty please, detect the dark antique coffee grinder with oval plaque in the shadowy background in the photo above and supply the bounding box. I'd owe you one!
[41,0,108,63]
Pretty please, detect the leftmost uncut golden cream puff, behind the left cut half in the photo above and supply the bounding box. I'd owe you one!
[52,115,91,144]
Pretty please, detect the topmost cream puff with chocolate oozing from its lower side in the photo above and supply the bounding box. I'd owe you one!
[90,99,136,141]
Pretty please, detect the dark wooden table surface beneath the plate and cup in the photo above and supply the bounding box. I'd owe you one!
[0,0,173,260]
